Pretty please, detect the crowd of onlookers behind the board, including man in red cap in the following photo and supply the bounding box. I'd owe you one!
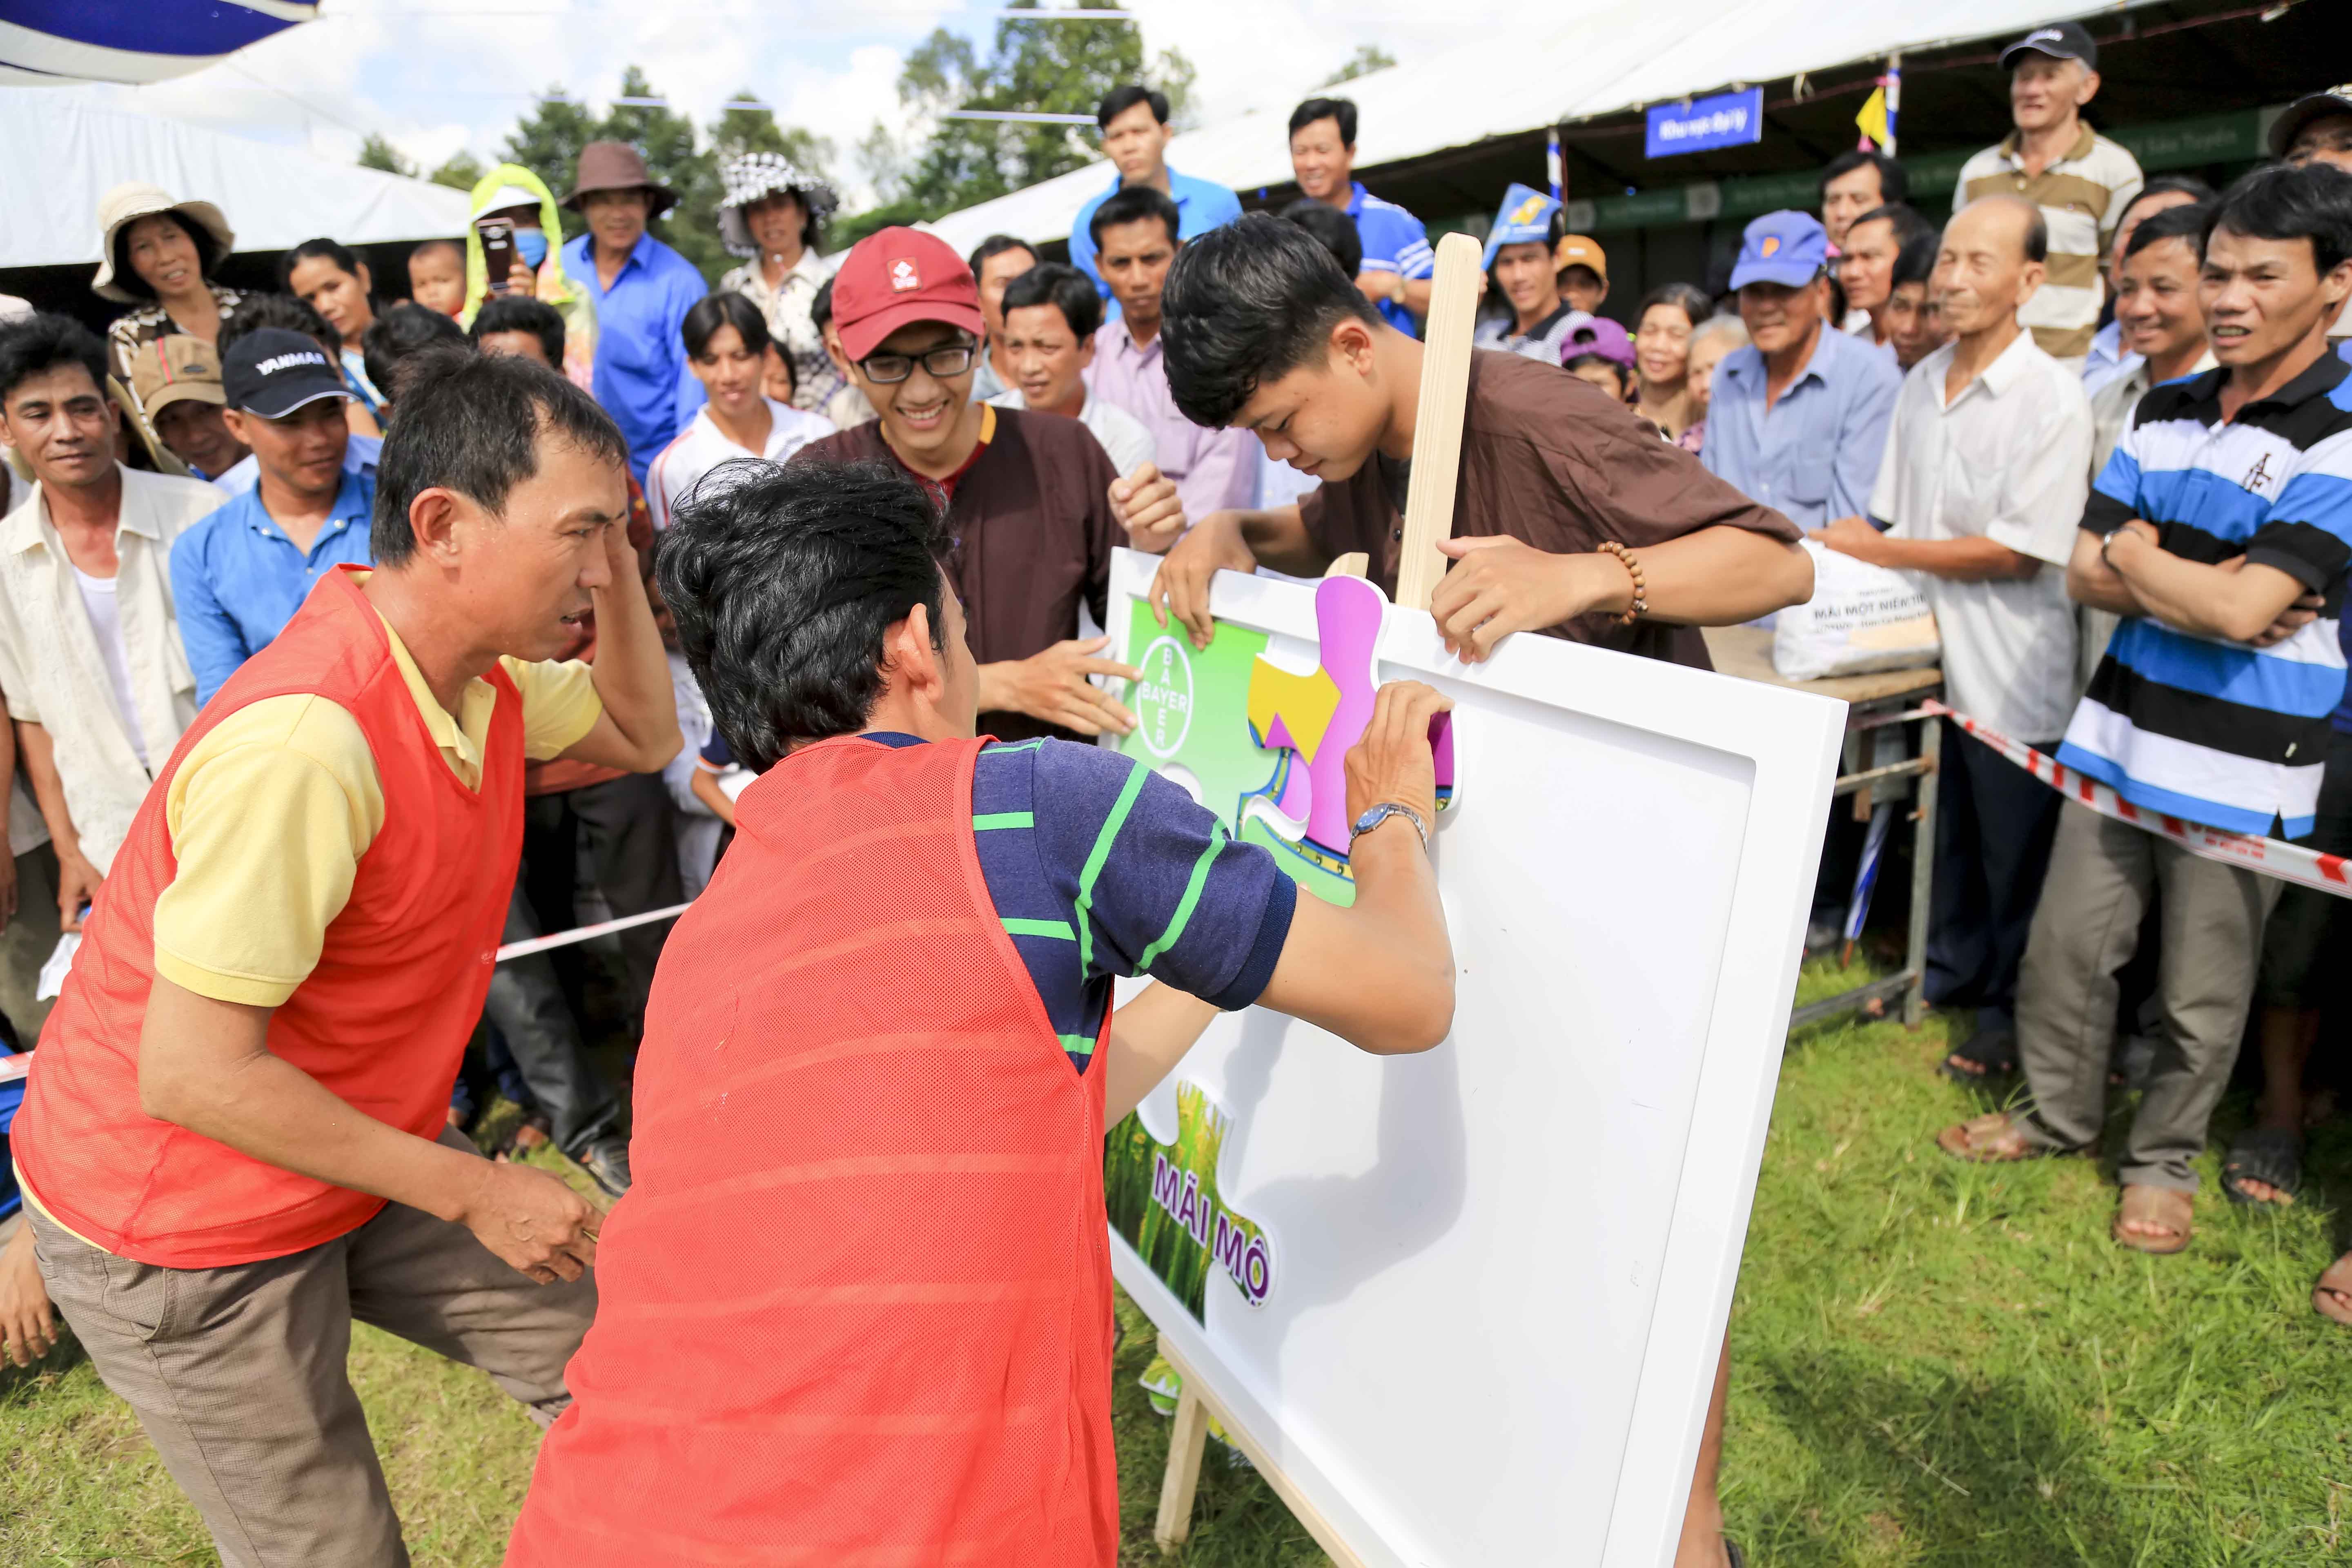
[0,24,2352,1561]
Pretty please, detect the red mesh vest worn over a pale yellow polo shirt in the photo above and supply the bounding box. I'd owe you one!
[9,569,522,1270]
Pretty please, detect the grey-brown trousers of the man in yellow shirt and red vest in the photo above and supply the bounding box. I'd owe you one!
[26,1131,595,1568]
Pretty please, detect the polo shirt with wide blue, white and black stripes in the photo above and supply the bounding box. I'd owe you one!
[2058,355,2352,839]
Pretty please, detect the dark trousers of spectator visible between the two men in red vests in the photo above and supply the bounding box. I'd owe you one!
[485,773,684,1154]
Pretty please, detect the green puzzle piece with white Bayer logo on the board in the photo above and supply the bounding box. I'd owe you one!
[1120,599,1355,905]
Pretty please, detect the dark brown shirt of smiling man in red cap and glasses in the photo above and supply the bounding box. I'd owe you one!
[793,409,1127,740]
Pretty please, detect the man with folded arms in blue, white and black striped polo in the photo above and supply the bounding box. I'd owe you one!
[1938,167,2352,1253]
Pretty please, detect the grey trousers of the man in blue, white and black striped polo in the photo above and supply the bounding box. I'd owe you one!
[2018,806,2284,1192]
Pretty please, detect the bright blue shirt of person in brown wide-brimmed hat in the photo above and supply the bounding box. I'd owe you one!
[564,235,710,484]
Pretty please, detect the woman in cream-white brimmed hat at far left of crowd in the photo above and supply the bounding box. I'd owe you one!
[89,183,242,416]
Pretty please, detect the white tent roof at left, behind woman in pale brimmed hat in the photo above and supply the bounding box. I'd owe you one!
[0,87,466,268]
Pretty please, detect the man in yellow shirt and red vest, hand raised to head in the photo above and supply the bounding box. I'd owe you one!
[9,350,680,1568]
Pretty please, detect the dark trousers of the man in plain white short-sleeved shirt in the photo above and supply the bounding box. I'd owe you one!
[1926,719,2065,1022]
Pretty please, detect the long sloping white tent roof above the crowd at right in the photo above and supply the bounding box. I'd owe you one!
[931,0,2145,252]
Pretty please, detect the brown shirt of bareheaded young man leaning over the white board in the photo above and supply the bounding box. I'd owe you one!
[1298,348,1799,670]
